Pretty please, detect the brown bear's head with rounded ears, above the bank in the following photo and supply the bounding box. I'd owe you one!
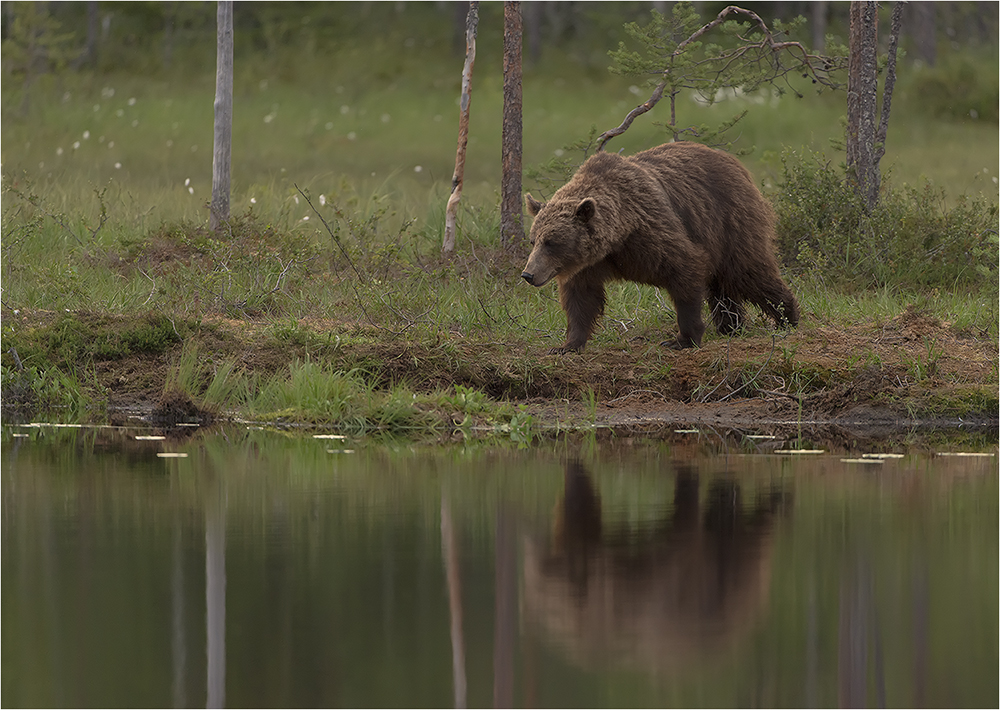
[521,193,601,286]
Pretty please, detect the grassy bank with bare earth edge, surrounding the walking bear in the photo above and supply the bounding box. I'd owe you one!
[0,4,1000,436]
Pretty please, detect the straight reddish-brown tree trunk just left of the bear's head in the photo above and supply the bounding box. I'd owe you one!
[500,0,524,247]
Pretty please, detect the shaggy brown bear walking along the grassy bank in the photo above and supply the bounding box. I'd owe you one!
[521,142,799,353]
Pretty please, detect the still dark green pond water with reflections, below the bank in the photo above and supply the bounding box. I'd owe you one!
[0,427,998,707]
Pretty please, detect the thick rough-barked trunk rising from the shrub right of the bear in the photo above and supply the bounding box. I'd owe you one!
[847,0,879,209]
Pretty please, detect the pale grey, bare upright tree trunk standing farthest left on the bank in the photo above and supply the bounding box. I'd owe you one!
[209,0,233,230]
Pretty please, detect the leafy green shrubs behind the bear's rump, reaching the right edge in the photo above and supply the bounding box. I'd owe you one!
[774,151,998,289]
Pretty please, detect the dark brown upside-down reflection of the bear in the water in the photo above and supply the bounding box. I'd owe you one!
[524,463,784,674]
